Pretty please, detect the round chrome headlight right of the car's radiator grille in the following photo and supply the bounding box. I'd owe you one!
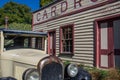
[67,64,78,77]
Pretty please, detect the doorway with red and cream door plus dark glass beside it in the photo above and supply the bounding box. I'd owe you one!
[97,18,120,68]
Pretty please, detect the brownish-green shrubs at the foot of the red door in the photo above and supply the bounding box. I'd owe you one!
[87,68,120,80]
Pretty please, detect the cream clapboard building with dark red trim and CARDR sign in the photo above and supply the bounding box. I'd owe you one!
[32,0,120,68]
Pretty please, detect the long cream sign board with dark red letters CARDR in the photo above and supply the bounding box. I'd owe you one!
[33,0,109,25]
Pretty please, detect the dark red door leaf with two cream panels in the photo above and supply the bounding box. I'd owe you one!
[99,20,114,68]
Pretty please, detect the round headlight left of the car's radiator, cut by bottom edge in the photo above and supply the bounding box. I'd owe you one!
[23,68,39,80]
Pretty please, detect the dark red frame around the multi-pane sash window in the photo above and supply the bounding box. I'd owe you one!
[60,24,74,54]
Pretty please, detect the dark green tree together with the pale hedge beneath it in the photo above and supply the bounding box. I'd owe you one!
[0,1,32,30]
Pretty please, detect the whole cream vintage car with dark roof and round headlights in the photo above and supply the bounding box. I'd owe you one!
[0,29,91,80]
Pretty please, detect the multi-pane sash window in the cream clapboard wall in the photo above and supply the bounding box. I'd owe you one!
[60,25,73,53]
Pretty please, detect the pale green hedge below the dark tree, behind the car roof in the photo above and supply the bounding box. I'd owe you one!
[0,23,31,31]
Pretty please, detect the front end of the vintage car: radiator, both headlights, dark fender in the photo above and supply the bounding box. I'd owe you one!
[23,55,92,80]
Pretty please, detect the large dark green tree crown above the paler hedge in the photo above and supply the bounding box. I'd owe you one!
[0,1,32,25]
